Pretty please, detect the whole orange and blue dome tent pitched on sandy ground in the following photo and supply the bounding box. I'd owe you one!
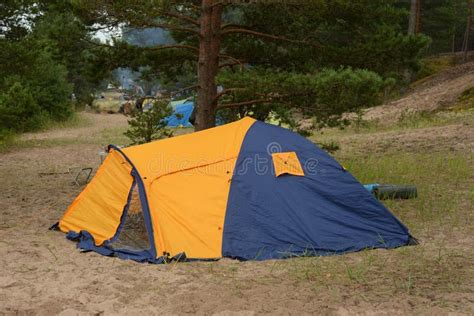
[52,118,414,263]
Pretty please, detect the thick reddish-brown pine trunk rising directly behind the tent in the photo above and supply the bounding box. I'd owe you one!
[195,0,222,131]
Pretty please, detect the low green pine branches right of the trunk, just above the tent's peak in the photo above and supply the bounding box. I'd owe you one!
[218,68,390,132]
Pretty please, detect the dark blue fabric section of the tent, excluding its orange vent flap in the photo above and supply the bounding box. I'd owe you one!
[222,122,410,260]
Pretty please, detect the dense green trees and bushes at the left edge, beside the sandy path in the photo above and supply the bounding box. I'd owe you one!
[0,0,108,136]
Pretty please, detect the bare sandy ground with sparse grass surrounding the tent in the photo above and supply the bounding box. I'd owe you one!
[0,108,474,315]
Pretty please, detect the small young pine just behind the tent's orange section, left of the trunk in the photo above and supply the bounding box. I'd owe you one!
[124,99,173,144]
